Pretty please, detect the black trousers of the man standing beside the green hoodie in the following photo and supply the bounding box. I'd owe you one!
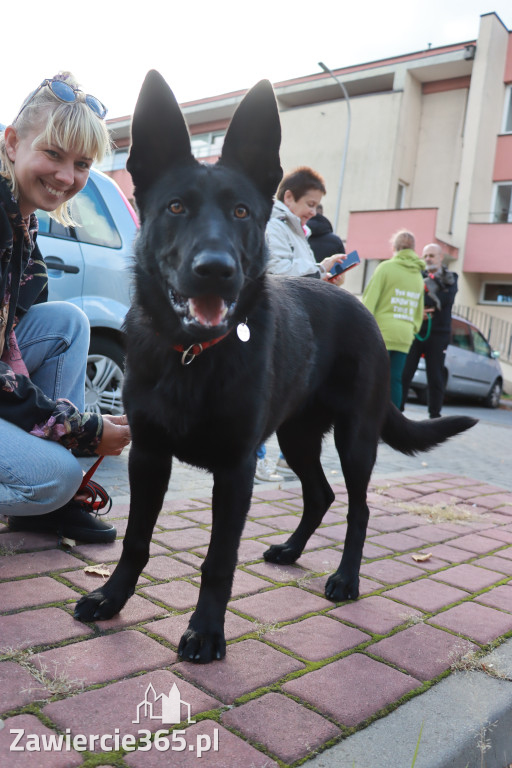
[402,332,450,419]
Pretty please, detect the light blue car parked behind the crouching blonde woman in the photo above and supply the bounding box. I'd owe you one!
[37,170,138,414]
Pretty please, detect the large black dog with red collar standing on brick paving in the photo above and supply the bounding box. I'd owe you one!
[75,71,475,662]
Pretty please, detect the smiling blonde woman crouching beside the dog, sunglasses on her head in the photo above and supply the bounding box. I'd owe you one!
[0,72,130,543]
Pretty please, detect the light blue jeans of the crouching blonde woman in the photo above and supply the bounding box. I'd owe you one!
[0,301,89,516]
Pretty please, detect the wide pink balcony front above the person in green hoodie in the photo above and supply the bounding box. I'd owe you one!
[346,208,458,259]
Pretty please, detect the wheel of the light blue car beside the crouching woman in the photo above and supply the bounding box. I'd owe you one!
[85,336,124,415]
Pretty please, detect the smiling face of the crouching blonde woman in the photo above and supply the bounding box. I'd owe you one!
[5,125,92,218]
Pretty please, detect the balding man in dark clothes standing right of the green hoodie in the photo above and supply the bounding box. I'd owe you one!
[402,243,457,419]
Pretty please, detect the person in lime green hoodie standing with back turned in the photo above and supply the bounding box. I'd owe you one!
[362,230,425,408]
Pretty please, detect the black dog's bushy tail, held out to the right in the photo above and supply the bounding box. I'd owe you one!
[381,402,478,456]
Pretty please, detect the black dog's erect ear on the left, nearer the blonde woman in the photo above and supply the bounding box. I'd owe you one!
[126,69,195,197]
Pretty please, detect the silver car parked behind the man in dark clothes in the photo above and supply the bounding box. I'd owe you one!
[410,315,503,408]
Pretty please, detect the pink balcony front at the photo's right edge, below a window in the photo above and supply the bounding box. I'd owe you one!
[464,223,512,275]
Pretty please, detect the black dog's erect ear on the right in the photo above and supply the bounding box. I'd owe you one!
[219,80,283,197]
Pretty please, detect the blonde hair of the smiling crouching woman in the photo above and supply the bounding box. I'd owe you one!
[0,72,110,226]
